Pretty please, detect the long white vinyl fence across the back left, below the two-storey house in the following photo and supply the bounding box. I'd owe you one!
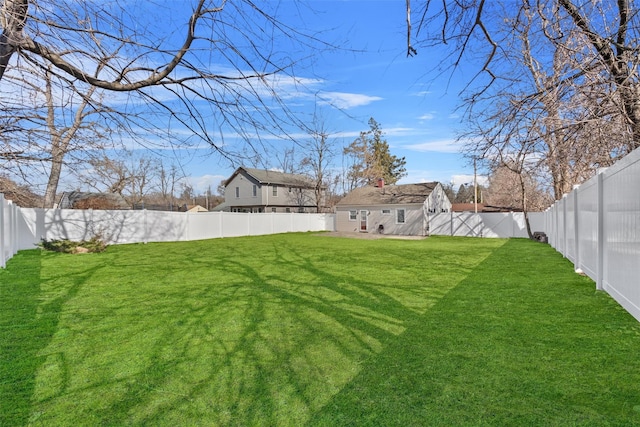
[8,209,334,256]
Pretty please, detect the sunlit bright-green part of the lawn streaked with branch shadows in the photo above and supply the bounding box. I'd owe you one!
[8,236,502,425]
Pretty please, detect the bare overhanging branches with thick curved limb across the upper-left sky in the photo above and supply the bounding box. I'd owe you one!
[0,0,336,194]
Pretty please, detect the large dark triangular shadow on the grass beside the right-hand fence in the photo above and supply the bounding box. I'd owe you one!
[307,239,640,427]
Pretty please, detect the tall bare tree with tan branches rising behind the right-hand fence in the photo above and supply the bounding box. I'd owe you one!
[408,0,640,207]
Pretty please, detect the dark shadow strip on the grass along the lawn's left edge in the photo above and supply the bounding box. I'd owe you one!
[0,250,103,426]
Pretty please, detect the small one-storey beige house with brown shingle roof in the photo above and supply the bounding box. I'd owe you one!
[336,182,451,236]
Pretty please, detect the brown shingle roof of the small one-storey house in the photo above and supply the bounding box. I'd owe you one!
[338,182,438,206]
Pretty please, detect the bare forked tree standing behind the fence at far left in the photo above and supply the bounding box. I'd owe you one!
[0,61,114,207]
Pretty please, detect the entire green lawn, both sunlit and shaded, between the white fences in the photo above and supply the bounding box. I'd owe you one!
[0,234,640,426]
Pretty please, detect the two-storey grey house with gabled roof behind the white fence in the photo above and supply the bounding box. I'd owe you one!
[214,167,324,212]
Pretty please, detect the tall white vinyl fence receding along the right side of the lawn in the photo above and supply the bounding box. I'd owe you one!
[545,146,640,321]
